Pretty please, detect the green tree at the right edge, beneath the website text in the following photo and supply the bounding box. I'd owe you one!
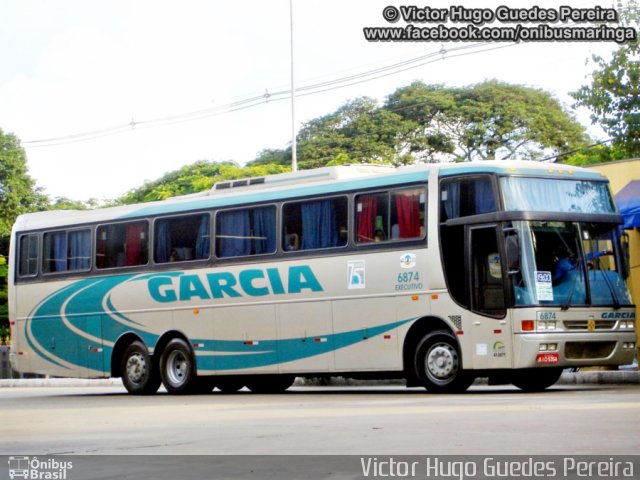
[570,0,640,157]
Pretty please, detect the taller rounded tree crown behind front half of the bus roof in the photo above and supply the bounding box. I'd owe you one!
[385,81,586,161]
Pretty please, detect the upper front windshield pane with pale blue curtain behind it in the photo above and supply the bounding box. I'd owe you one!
[500,177,615,213]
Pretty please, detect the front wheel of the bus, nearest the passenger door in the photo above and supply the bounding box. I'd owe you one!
[415,330,474,393]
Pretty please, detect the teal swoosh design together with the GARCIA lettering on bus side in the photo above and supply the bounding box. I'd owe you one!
[24,265,415,376]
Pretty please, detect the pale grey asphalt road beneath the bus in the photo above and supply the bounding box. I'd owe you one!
[0,385,640,455]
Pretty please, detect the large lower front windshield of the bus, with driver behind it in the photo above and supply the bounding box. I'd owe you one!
[513,221,631,309]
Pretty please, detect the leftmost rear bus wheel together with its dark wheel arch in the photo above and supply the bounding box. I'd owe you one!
[117,334,160,395]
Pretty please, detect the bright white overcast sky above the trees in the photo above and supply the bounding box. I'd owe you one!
[0,0,617,200]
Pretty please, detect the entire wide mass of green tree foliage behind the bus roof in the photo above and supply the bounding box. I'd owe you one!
[250,81,586,169]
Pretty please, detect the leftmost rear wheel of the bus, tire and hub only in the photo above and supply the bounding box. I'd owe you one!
[120,340,160,395]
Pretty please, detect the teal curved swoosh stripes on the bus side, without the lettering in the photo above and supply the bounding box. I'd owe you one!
[27,272,414,372]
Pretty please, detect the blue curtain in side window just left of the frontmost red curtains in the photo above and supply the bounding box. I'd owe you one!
[300,200,338,250]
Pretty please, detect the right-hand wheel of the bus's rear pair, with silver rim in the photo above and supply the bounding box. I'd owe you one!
[160,338,196,394]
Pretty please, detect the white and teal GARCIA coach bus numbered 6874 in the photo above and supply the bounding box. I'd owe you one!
[9,162,635,394]
